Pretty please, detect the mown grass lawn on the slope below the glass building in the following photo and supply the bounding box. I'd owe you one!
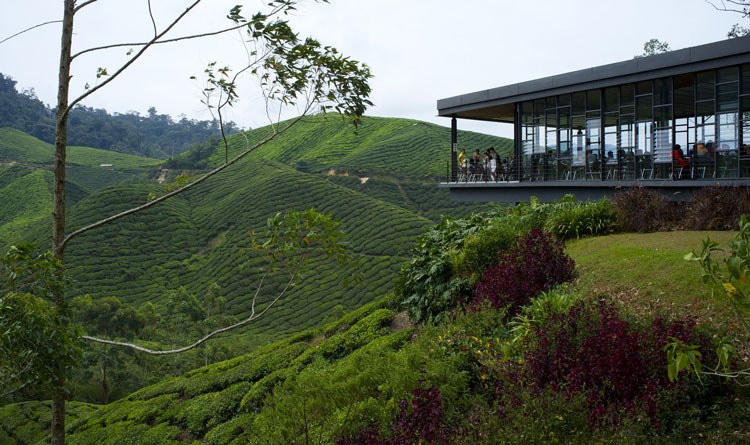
[566,232,739,330]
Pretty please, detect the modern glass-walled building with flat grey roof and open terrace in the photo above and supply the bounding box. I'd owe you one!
[437,36,750,201]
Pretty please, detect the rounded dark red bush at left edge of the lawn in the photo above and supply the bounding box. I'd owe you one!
[472,229,575,314]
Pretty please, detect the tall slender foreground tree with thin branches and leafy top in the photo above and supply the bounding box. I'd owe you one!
[6,0,371,444]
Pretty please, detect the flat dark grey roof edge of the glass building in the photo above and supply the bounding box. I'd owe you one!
[437,35,750,123]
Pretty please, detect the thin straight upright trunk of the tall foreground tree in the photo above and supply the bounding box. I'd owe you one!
[52,0,75,445]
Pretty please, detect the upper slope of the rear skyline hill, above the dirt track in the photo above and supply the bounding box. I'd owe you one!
[197,115,512,180]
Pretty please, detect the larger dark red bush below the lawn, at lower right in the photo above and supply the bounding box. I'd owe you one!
[518,303,705,426]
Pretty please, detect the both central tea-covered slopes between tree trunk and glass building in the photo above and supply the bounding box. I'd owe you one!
[2,116,508,344]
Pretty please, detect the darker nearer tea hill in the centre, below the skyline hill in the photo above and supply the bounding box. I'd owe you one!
[58,160,431,335]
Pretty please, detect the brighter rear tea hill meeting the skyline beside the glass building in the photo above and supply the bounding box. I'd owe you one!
[173,115,513,222]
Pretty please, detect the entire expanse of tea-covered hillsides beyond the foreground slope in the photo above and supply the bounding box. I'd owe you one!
[0,116,509,401]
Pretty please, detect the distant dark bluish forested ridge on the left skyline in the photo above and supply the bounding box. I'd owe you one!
[0,73,240,159]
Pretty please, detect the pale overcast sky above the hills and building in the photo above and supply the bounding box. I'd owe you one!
[0,0,747,136]
